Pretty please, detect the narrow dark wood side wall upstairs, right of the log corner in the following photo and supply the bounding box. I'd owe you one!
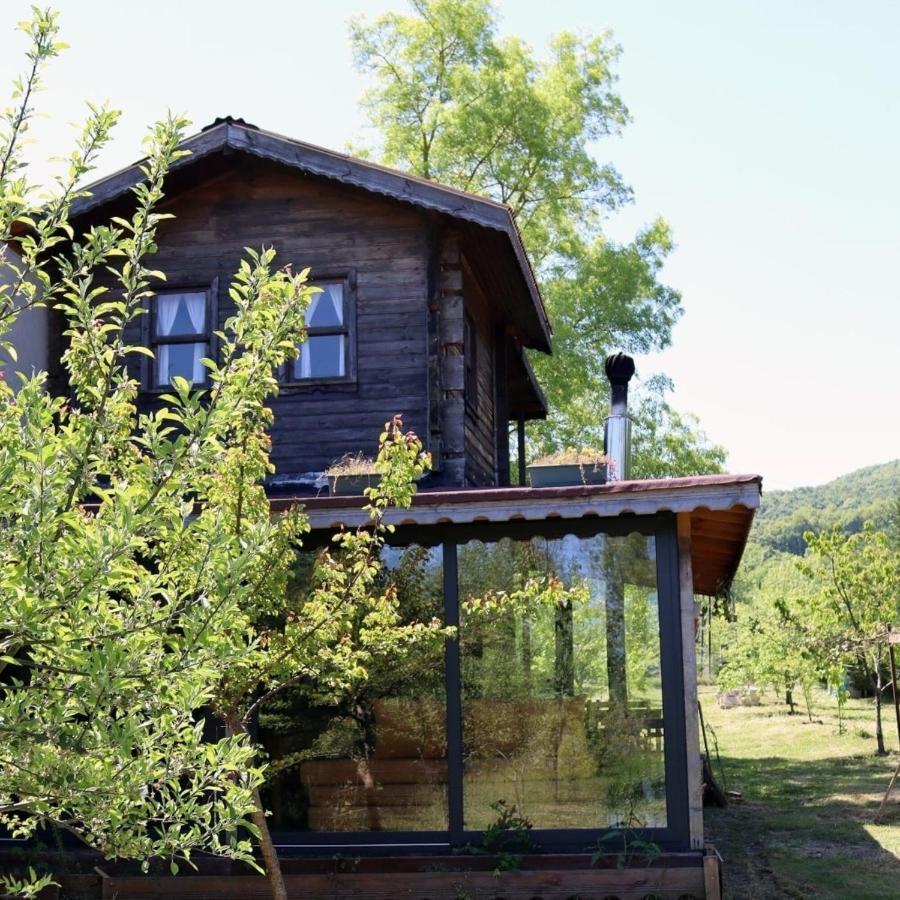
[463,266,497,486]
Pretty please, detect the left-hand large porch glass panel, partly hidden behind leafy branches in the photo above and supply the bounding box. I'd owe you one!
[259,546,448,831]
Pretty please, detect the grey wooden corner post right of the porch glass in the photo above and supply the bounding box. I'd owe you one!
[676,513,704,852]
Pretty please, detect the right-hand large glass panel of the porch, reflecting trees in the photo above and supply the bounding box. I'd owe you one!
[459,534,666,829]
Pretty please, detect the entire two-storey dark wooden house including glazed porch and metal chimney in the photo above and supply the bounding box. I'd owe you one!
[3,118,761,900]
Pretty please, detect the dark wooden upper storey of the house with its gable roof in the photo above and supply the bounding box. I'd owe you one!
[59,118,550,489]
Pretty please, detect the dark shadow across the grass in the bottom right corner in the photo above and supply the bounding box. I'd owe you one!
[706,756,900,900]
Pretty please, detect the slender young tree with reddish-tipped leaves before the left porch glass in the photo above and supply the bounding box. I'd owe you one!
[211,418,447,900]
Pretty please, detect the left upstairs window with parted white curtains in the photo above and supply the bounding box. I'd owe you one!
[152,291,209,388]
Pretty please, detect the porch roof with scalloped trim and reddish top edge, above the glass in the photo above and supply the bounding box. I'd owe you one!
[271,475,762,595]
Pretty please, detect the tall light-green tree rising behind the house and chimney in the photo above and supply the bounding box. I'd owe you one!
[351,0,724,476]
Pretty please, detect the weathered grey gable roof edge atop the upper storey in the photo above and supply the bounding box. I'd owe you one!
[71,116,552,353]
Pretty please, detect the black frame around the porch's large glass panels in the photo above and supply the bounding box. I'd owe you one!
[273,513,691,855]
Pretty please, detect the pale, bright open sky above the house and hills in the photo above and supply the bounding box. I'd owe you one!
[0,0,900,489]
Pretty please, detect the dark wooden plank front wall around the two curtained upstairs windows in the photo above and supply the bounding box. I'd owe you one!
[121,160,429,474]
